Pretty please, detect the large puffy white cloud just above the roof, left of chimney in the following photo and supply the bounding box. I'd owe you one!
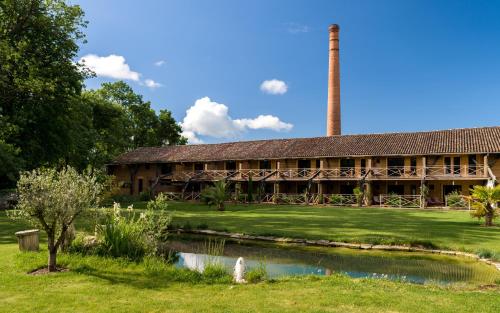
[180,97,293,144]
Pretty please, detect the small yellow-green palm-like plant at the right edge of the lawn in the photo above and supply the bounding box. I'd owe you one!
[471,185,500,226]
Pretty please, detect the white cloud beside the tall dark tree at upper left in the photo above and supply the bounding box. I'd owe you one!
[79,54,141,81]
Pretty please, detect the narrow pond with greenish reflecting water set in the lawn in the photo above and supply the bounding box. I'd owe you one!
[164,235,500,284]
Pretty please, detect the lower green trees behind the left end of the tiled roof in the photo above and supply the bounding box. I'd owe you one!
[82,81,186,167]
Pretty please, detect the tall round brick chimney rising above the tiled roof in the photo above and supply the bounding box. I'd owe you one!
[326,24,341,136]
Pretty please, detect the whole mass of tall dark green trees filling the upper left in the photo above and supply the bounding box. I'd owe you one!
[0,0,186,183]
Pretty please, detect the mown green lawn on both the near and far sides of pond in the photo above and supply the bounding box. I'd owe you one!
[0,204,500,312]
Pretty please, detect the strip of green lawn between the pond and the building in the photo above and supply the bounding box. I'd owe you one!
[160,202,500,258]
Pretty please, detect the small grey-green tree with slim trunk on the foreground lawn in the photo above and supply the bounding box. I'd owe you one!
[9,167,103,272]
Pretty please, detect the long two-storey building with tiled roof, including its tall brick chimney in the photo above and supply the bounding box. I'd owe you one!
[108,25,500,206]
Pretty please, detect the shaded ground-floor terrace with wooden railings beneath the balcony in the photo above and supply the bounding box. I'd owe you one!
[156,180,487,209]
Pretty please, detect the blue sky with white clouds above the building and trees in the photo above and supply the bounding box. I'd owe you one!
[74,0,500,142]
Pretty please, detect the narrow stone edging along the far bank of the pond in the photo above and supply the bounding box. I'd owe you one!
[178,229,500,271]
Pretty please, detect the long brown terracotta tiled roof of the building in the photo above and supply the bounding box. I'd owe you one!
[114,126,500,164]
